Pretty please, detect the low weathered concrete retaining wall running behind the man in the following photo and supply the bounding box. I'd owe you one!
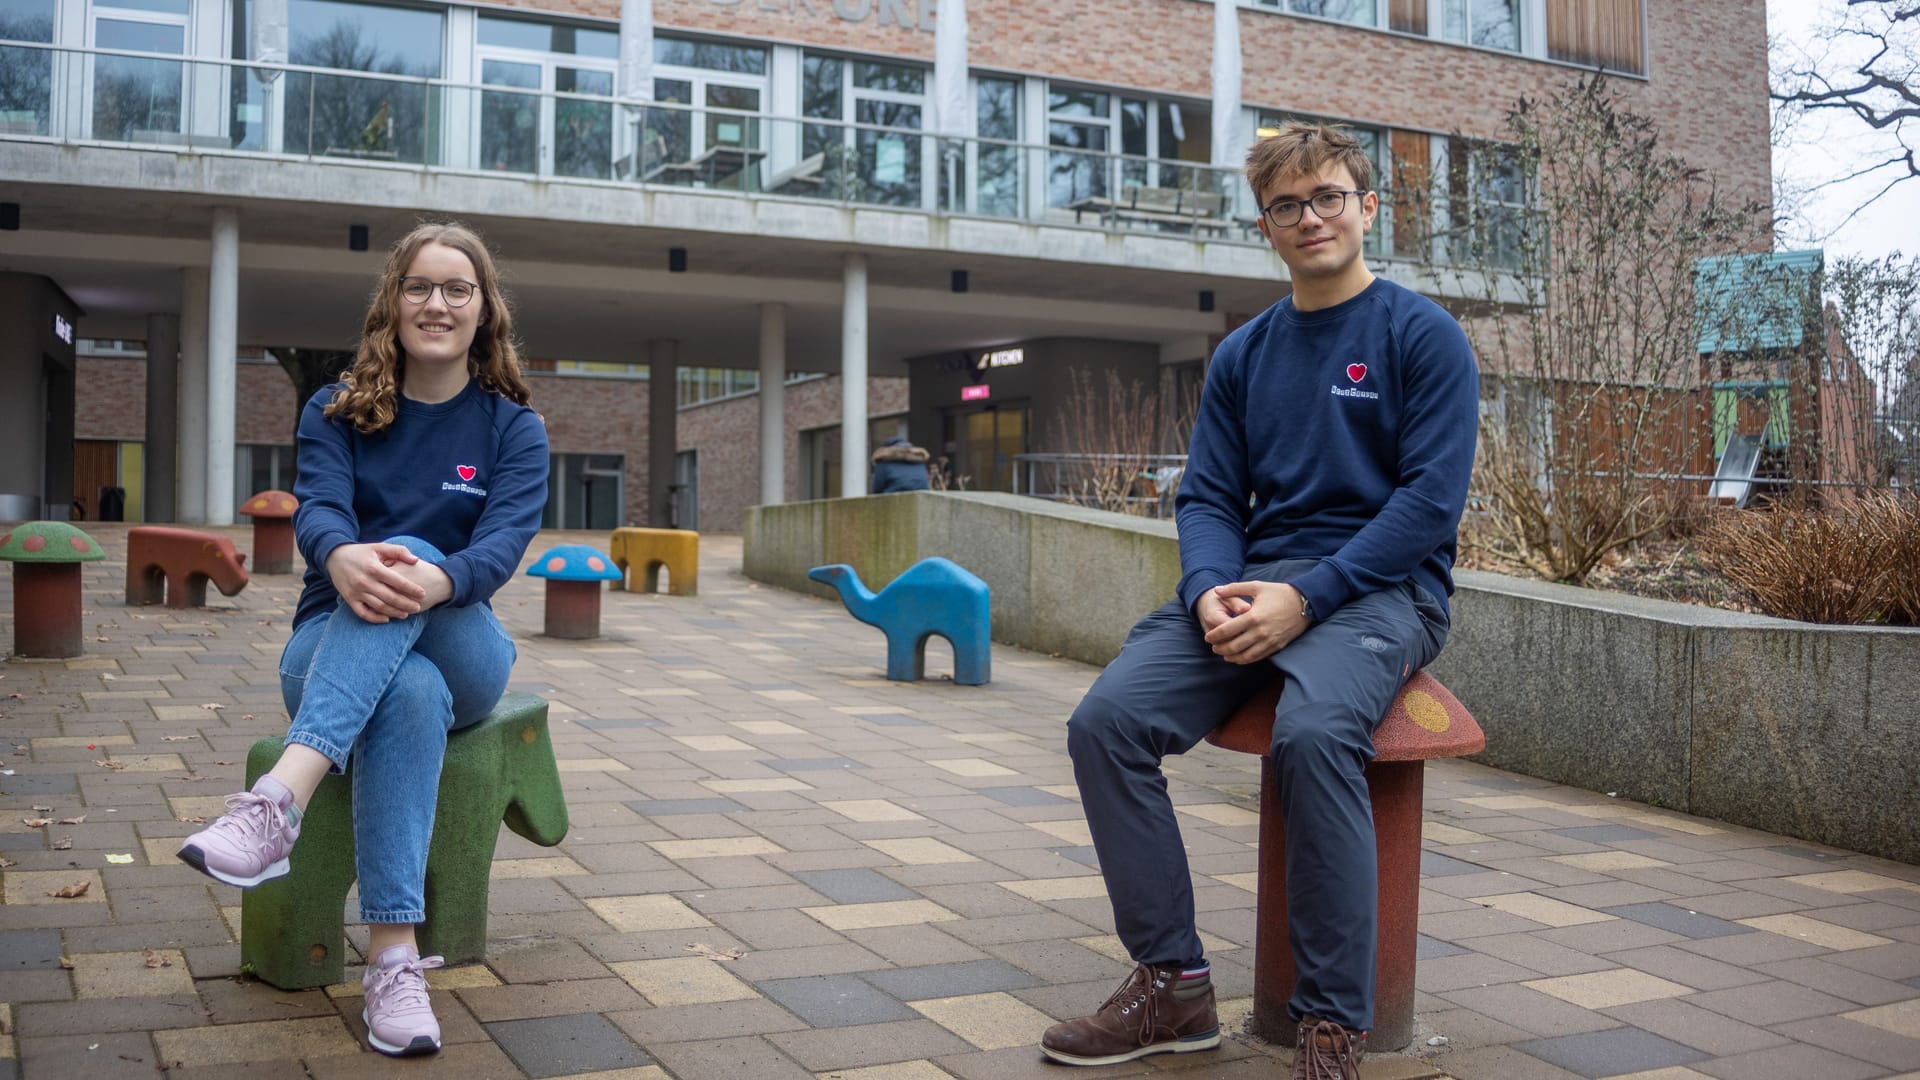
[745,492,1920,863]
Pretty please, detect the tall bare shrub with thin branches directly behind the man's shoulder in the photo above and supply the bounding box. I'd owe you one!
[1396,77,1764,584]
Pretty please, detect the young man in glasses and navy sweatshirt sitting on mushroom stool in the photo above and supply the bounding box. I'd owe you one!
[1041,125,1478,1080]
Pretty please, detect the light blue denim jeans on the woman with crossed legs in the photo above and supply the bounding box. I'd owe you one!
[280,536,516,922]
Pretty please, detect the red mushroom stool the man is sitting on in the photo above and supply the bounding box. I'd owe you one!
[1206,671,1486,1051]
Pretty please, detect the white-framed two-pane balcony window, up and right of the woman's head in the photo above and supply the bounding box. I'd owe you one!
[476,15,620,179]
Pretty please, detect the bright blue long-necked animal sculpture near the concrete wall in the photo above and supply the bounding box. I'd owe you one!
[806,557,993,686]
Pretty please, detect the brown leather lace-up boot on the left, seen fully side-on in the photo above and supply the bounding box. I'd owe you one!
[1041,965,1219,1065]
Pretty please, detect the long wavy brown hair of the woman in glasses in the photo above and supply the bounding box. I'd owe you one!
[326,221,528,434]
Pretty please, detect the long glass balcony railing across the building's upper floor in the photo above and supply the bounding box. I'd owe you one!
[0,40,1260,244]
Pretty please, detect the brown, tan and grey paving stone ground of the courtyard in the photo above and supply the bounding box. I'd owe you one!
[0,525,1920,1080]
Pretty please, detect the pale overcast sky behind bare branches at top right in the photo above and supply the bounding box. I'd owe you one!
[1766,0,1920,258]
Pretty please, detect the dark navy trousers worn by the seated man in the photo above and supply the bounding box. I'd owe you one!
[1068,559,1448,1030]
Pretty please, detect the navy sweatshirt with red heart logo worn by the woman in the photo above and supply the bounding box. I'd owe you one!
[294,380,547,626]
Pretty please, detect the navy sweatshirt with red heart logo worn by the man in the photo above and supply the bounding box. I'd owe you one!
[1175,279,1480,619]
